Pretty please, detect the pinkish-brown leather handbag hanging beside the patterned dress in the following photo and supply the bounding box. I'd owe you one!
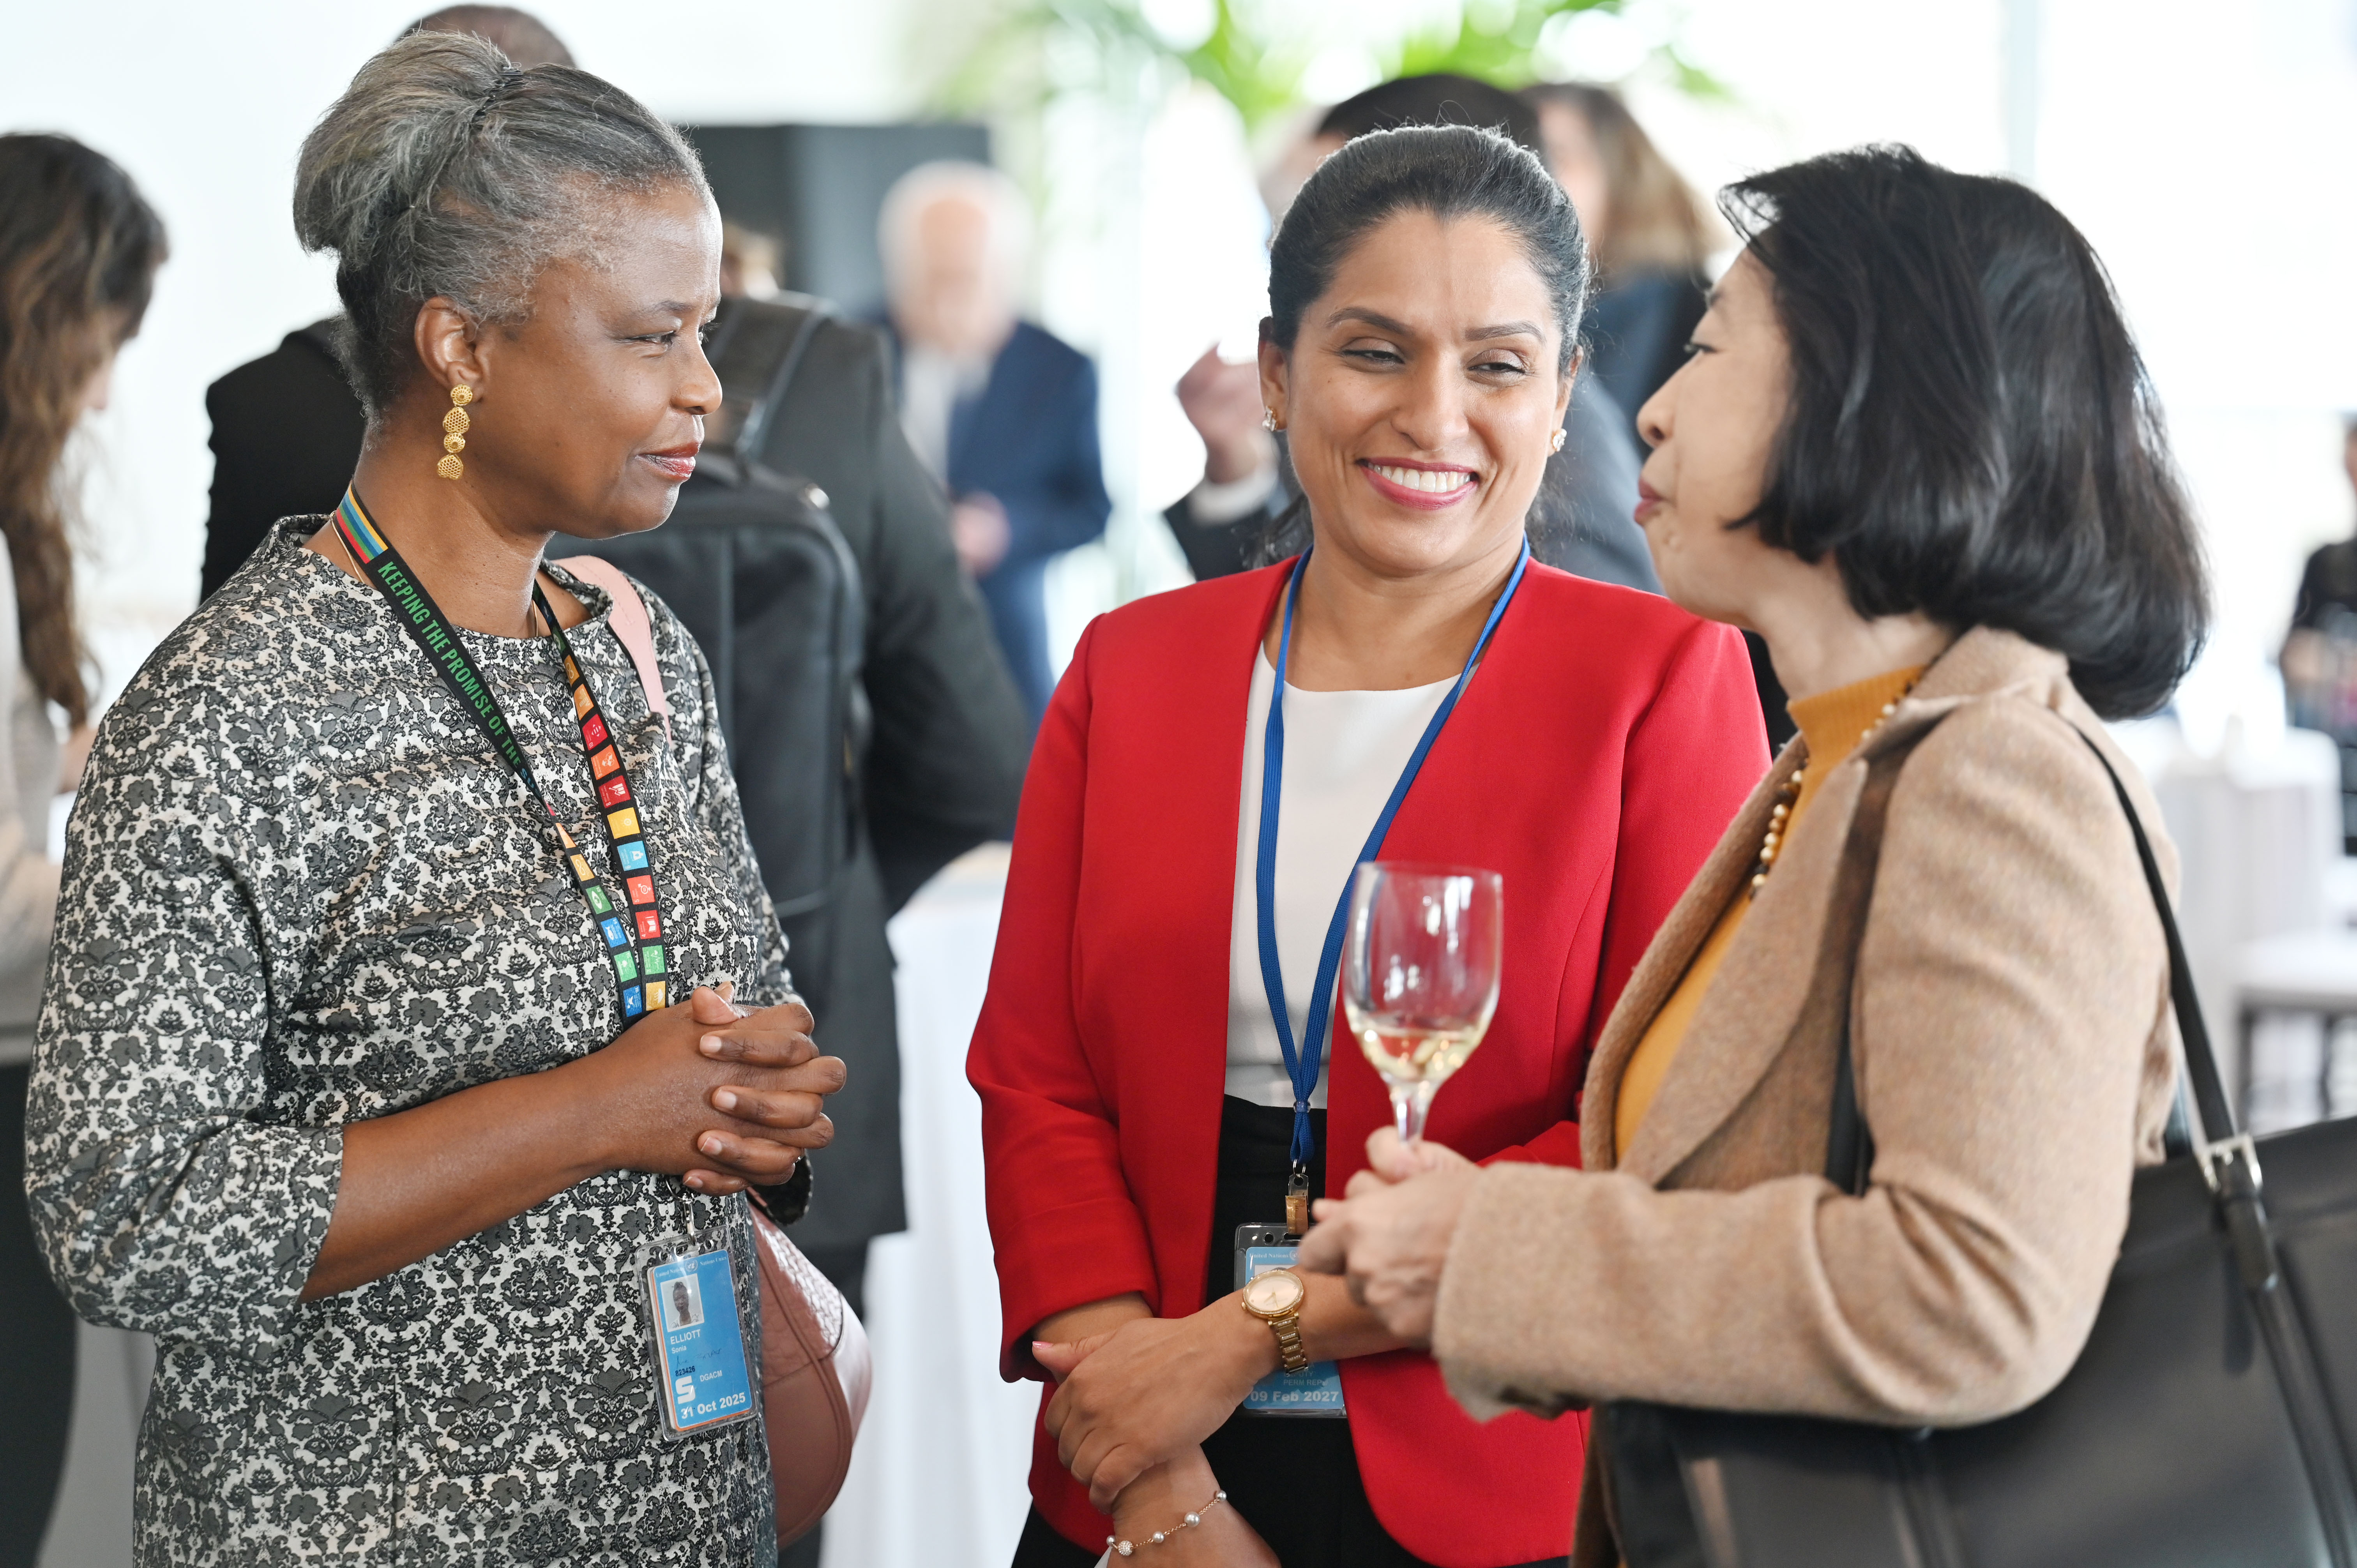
[752,1207,870,1547]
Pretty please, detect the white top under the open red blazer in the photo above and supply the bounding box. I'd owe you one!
[1228,651,1457,1108]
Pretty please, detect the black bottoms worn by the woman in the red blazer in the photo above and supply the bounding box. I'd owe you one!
[1014,1097,1572,1568]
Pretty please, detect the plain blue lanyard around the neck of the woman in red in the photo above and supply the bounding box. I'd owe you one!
[1251,540,1530,1174]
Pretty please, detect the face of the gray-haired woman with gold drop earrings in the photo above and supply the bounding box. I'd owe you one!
[433,186,721,538]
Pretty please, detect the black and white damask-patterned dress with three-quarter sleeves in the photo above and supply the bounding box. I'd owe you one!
[26,519,787,1568]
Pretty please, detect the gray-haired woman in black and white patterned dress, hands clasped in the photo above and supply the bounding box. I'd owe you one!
[28,35,841,1568]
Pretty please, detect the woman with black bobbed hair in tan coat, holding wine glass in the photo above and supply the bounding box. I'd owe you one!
[1304,148,2206,1563]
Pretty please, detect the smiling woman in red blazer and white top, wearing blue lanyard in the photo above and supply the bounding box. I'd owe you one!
[969,127,1768,1568]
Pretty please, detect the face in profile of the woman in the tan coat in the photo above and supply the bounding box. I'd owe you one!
[1636,250,1791,630]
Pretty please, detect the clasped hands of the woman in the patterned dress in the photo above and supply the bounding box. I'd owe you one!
[573,985,844,1195]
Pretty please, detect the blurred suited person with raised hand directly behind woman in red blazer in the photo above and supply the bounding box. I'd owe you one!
[1164,73,1662,592]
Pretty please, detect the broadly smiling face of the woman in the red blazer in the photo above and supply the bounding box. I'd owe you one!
[1261,201,1572,578]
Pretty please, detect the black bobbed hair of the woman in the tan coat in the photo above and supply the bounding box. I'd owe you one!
[1718,146,2209,719]
